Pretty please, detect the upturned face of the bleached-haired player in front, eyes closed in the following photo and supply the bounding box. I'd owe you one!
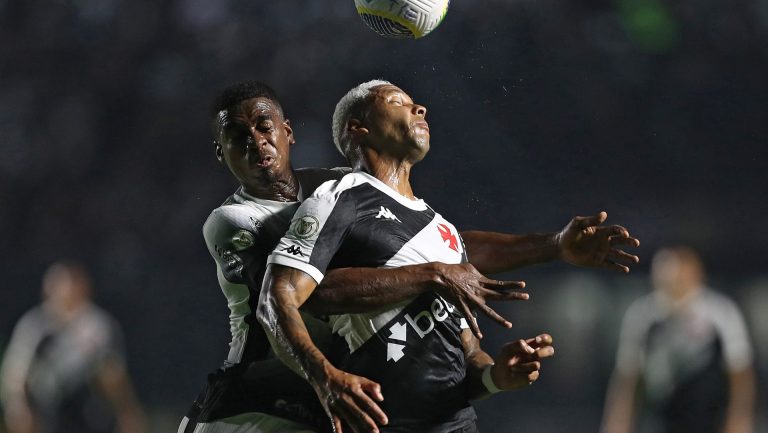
[362,85,429,162]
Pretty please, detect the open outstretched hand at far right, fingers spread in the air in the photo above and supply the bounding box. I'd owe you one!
[556,212,640,273]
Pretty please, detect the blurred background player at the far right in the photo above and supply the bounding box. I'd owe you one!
[602,247,755,433]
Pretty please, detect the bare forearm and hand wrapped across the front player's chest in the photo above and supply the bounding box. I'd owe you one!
[302,262,528,338]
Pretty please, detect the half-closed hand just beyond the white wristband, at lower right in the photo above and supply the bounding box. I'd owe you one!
[491,334,555,391]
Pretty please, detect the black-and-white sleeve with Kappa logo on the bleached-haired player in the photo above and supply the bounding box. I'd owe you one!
[268,183,356,284]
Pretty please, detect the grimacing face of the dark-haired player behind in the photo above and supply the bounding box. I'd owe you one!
[216,97,295,187]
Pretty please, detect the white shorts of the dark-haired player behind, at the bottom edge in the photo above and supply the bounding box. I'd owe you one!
[178,412,317,433]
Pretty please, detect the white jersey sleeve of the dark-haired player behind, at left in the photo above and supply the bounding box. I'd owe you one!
[203,205,274,290]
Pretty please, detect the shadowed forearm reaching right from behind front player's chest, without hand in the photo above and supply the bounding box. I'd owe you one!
[461,231,558,274]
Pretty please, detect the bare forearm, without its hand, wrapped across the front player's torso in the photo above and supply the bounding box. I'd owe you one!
[302,263,440,314]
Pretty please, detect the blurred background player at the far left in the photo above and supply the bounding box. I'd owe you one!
[1,262,145,433]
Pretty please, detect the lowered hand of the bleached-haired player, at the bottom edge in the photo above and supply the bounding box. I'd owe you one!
[312,366,388,433]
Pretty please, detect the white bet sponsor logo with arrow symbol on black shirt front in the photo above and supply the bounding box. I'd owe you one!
[387,296,464,362]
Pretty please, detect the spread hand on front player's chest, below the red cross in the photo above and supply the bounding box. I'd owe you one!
[435,263,528,338]
